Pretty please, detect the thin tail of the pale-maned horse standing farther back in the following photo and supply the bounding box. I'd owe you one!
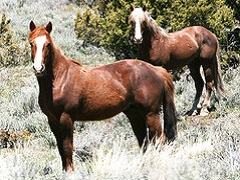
[212,43,225,94]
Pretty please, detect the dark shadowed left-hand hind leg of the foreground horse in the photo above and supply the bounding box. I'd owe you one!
[124,106,148,152]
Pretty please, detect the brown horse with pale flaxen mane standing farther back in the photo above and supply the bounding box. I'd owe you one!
[129,6,224,115]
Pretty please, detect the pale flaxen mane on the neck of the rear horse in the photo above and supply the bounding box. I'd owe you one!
[144,11,168,38]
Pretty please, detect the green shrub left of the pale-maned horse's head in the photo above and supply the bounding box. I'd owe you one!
[75,1,136,59]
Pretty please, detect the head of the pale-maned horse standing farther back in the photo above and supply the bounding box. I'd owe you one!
[129,6,146,44]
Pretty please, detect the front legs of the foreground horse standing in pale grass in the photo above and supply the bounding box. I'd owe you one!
[49,113,74,171]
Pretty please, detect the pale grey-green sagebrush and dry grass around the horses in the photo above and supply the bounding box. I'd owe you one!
[0,0,240,180]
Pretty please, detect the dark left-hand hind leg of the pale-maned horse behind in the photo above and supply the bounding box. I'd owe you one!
[188,62,204,115]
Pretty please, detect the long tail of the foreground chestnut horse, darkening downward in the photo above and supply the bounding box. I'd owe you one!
[158,67,178,141]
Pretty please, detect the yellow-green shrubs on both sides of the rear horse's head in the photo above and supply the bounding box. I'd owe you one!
[75,0,234,59]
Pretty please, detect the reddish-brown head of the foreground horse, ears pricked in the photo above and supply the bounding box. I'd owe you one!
[29,21,52,77]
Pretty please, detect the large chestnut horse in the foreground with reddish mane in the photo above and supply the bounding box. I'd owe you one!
[29,21,177,171]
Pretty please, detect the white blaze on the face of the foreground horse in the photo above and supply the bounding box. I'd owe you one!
[33,36,47,71]
